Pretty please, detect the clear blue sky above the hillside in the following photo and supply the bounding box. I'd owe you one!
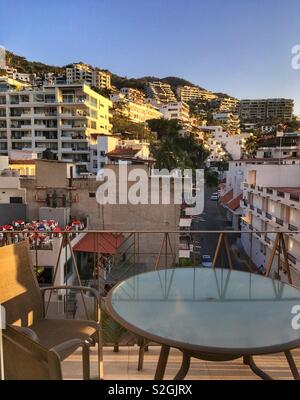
[0,0,300,114]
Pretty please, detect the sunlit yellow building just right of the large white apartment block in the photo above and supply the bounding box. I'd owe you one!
[110,93,163,123]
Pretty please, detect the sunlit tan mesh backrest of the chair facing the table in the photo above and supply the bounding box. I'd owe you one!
[0,241,43,326]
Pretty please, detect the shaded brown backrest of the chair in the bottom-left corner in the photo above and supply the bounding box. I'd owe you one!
[2,326,62,380]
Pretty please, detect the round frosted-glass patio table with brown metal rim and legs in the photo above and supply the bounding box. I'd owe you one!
[106,267,300,379]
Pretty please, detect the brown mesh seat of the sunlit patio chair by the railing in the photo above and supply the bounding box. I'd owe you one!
[30,319,97,360]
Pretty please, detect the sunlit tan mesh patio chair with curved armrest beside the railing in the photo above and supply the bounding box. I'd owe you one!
[0,241,103,379]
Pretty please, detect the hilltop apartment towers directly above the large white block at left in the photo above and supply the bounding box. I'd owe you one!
[66,63,111,89]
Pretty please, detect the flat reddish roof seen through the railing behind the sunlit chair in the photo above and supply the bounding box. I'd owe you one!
[73,233,124,254]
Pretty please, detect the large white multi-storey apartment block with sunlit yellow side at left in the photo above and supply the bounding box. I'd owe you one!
[0,84,112,172]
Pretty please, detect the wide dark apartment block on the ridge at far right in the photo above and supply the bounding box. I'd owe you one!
[239,98,294,122]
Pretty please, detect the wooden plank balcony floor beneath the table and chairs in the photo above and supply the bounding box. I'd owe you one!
[63,346,300,380]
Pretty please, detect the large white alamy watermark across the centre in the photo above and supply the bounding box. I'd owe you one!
[96,164,204,215]
